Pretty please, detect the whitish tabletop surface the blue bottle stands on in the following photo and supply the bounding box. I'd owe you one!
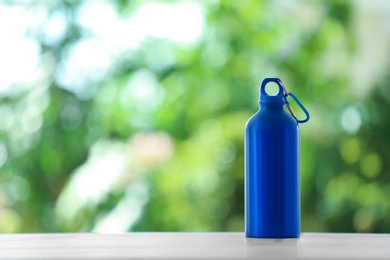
[0,233,390,259]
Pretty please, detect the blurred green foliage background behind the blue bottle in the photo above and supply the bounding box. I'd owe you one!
[0,0,390,232]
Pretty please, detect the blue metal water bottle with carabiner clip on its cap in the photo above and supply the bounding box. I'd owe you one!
[245,78,310,238]
